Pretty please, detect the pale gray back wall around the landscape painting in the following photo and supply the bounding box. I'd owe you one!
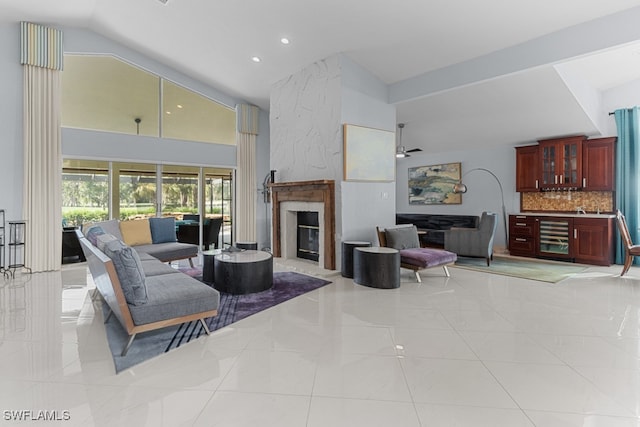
[396,147,520,247]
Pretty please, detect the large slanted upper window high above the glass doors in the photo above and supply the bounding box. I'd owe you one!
[62,55,236,145]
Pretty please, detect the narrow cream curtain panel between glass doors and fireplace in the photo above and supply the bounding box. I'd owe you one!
[234,132,258,242]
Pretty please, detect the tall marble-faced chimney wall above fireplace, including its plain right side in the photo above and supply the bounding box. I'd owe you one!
[270,55,396,259]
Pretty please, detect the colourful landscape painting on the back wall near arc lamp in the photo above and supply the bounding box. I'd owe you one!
[409,163,462,205]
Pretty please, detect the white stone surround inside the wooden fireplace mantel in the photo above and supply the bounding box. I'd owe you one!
[280,202,324,267]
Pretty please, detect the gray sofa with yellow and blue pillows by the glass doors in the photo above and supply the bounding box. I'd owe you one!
[83,217,198,266]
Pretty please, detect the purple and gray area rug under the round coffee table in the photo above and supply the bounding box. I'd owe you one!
[105,268,331,372]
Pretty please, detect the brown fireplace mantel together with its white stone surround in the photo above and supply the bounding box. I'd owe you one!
[270,180,336,270]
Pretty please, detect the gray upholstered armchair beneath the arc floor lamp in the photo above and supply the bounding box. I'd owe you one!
[444,212,498,265]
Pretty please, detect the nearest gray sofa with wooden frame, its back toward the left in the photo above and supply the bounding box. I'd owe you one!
[76,230,220,356]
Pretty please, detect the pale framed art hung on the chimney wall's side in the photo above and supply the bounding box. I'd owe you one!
[342,124,396,182]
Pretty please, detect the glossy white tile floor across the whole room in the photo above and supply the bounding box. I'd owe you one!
[0,264,640,427]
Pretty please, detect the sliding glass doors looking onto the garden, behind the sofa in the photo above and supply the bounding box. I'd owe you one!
[62,159,233,246]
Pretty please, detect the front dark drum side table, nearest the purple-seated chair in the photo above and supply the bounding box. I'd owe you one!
[353,247,400,289]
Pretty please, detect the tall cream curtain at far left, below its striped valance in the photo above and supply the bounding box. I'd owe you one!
[23,65,62,272]
